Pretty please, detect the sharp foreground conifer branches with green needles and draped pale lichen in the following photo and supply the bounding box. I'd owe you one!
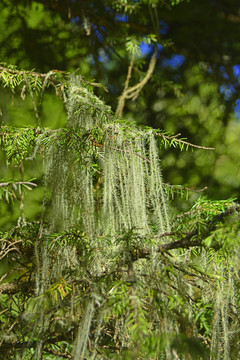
[0,65,240,360]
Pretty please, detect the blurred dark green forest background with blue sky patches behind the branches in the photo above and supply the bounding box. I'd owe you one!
[0,0,240,231]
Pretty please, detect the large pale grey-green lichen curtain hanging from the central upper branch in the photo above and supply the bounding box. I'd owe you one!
[45,79,169,237]
